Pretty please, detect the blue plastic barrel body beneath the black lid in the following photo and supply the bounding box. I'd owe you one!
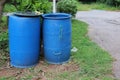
[8,15,40,68]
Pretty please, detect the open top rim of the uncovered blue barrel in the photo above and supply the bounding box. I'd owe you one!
[42,13,71,19]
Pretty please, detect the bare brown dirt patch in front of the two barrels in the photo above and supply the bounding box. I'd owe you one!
[0,61,79,80]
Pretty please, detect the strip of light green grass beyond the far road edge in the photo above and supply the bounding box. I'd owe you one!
[77,2,120,11]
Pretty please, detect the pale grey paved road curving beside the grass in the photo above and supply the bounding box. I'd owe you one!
[76,10,120,79]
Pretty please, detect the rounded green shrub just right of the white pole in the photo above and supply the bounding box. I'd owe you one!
[57,0,77,16]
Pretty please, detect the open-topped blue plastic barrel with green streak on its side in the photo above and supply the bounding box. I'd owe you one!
[43,13,71,64]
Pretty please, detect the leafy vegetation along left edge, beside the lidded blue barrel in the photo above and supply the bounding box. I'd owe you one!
[0,11,9,67]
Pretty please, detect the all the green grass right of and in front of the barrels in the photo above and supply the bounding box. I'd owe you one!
[0,20,114,80]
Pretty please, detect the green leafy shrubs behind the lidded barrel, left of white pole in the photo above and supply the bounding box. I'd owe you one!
[10,0,51,13]
